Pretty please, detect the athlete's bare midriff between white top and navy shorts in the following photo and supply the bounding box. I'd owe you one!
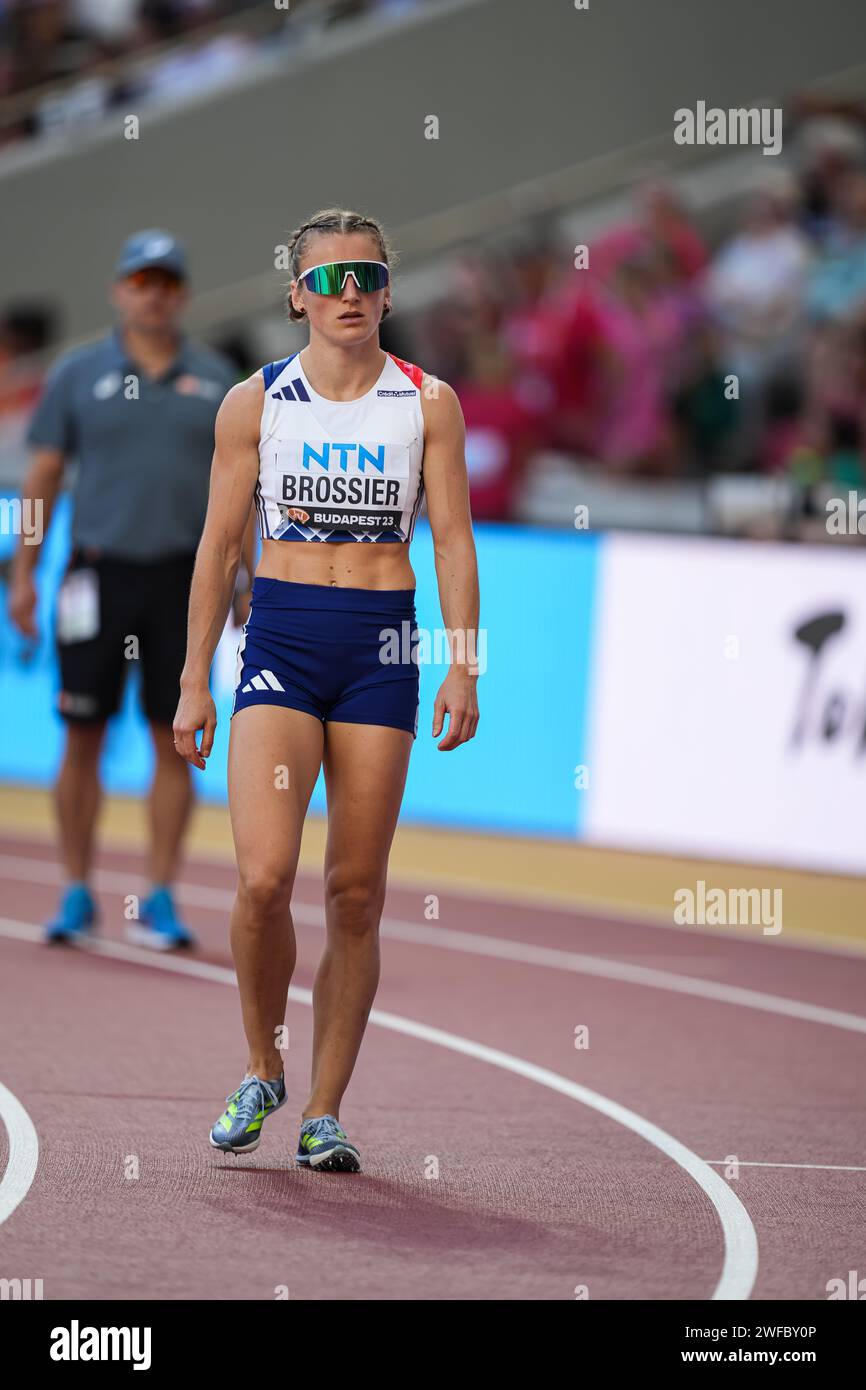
[256,541,416,589]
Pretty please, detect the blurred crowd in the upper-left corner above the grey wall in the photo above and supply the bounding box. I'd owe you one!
[0,0,431,145]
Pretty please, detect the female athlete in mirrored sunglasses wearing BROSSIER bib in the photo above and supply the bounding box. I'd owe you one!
[174,210,478,1172]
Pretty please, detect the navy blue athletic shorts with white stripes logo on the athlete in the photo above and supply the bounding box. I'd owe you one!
[232,578,418,738]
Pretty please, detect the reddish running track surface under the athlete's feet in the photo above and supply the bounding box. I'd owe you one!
[0,837,866,1300]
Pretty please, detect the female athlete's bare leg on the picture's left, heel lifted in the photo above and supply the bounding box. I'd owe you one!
[228,705,324,1080]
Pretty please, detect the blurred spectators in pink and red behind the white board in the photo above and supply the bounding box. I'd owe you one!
[405,101,866,518]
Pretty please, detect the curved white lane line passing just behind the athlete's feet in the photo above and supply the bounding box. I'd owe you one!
[0,917,758,1300]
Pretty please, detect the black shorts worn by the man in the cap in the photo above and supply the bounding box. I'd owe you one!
[56,550,195,724]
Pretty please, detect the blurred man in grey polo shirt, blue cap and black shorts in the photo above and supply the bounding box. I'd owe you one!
[10,231,239,949]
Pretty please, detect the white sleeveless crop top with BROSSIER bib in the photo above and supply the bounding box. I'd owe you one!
[256,353,424,541]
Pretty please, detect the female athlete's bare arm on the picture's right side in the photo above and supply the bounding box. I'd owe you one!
[421,377,478,752]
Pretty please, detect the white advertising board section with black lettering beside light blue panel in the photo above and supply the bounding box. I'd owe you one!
[582,535,866,874]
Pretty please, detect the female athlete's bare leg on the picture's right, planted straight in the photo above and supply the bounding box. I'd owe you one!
[303,721,413,1119]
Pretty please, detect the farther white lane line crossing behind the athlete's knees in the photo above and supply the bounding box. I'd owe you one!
[0,855,866,1034]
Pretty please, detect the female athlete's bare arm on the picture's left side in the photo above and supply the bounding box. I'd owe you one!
[174,374,264,767]
